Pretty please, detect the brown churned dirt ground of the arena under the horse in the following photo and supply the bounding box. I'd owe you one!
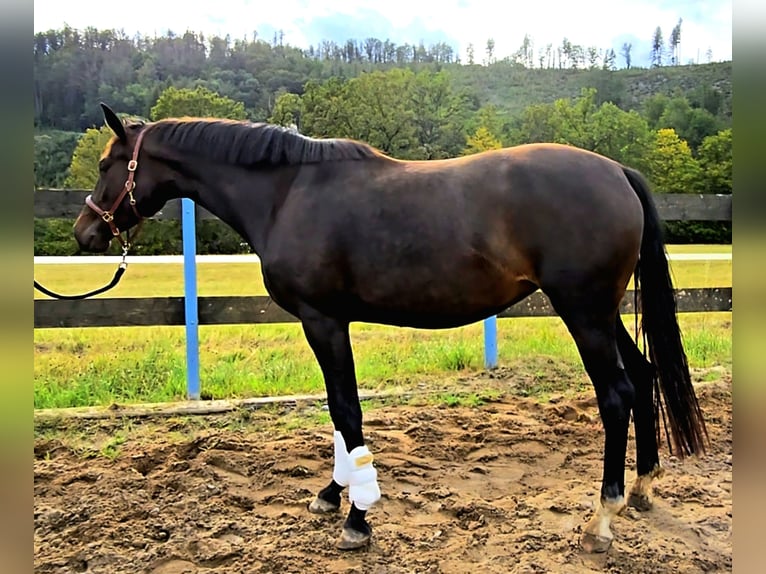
[34,377,732,574]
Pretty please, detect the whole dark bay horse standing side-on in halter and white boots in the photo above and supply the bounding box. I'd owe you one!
[74,104,708,552]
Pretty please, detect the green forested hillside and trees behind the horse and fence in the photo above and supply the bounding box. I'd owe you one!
[34,27,731,253]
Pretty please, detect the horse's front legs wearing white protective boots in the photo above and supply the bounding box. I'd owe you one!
[300,309,380,550]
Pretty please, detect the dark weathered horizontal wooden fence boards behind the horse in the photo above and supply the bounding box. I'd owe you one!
[34,190,732,328]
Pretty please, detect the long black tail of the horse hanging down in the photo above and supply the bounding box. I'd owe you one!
[623,167,707,458]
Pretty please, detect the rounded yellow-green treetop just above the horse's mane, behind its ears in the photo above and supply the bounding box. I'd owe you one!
[151,86,247,121]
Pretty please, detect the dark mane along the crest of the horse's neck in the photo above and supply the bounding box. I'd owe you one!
[146,118,381,167]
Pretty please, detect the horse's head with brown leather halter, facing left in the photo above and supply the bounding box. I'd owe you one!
[74,103,161,253]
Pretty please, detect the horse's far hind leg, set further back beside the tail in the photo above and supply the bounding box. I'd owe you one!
[617,317,663,510]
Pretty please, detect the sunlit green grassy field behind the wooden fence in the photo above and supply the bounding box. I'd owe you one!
[34,245,731,408]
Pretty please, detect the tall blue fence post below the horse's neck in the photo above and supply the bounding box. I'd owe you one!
[181,198,200,400]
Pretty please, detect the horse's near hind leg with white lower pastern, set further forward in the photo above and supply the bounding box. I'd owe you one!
[549,293,634,552]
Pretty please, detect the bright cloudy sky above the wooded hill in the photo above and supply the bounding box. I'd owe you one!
[34,0,732,67]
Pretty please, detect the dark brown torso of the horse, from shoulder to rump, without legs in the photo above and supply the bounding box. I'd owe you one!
[263,145,643,326]
